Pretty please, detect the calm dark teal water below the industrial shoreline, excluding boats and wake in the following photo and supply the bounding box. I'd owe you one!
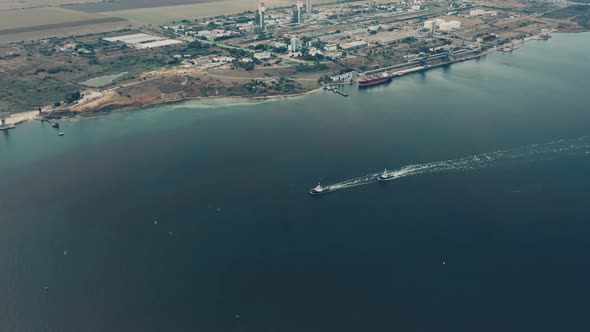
[0,34,590,331]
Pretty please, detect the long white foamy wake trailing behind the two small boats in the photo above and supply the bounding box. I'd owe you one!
[326,136,590,191]
